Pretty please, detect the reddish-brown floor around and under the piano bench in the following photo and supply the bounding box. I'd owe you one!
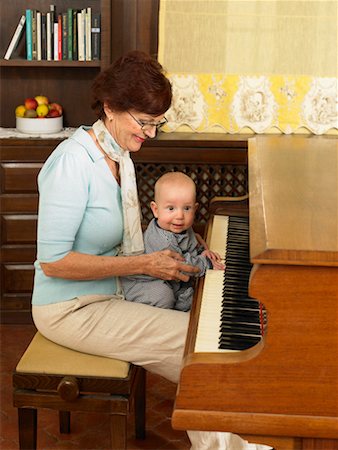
[0,325,190,450]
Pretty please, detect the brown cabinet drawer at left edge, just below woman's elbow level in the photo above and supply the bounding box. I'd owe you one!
[2,264,34,294]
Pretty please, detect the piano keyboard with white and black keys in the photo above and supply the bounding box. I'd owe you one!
[195,216,265,352]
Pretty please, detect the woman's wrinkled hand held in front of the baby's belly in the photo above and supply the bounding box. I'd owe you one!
[143,250,199,281]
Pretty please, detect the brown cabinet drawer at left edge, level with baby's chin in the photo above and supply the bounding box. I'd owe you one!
[1,214,38,244]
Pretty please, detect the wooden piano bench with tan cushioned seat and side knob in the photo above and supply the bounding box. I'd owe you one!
[13,332,146,450]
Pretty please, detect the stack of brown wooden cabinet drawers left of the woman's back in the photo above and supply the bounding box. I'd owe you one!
[0,139,58,323]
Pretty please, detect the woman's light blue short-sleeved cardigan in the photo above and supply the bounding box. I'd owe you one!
[32,126,123,305]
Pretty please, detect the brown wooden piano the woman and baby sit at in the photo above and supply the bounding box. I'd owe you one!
[172,136,338,450]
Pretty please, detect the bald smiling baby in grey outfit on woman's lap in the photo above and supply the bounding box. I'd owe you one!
[121,172,224,311]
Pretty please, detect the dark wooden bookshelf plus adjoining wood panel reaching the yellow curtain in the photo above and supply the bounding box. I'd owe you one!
[0,0,160,128]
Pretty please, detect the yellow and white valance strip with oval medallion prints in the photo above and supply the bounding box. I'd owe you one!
[164,73,338,134]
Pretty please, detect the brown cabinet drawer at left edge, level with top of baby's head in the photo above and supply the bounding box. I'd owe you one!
[1,163,43,194]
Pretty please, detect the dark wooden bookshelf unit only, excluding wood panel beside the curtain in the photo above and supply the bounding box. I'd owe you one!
[0,0,112,128]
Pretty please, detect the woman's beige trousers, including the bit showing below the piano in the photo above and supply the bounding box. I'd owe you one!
[32,296,268,450]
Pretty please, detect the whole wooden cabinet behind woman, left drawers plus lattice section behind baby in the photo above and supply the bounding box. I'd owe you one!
[0,133,247,323]
